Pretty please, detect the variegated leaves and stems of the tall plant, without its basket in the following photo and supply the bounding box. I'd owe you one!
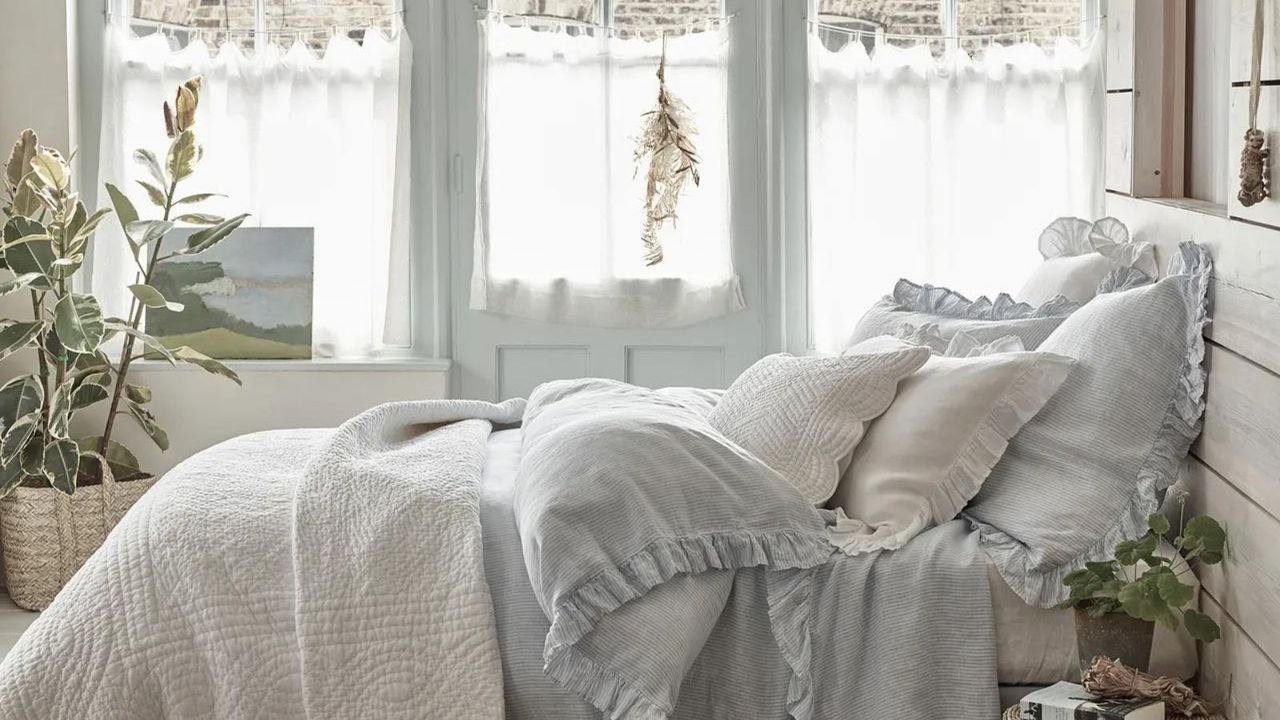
[0,77,246,497]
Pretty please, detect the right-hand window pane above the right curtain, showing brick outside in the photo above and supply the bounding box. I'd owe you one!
[956,0,1084,50]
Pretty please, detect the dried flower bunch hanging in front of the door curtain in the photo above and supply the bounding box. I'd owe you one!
[635,36,701,266]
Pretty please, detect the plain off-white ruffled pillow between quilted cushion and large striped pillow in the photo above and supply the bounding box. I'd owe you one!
[828,334,1074,555]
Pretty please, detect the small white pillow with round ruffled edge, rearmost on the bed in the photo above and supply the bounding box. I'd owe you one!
[1016,217,1158,305]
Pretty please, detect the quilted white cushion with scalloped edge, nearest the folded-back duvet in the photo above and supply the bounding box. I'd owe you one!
[708,343,929,505]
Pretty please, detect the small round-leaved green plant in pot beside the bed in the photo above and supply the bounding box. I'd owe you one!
[1062,493,1226,671]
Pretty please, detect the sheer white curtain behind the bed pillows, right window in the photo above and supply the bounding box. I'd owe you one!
[808,33,1105,351]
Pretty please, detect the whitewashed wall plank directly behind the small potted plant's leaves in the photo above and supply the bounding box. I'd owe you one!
[1183,460,1280,666]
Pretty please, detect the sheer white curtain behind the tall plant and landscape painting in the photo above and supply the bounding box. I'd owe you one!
[92,23,412,357]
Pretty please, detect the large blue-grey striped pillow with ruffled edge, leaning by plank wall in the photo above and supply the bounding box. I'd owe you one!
[964,242,1212,607]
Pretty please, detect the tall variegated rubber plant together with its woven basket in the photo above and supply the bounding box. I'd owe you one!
[0,78,246,610]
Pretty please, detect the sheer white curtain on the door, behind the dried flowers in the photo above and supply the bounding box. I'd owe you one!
[471,18,744,327]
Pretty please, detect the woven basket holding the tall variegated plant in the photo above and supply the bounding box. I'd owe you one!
[0,477,156,610]
